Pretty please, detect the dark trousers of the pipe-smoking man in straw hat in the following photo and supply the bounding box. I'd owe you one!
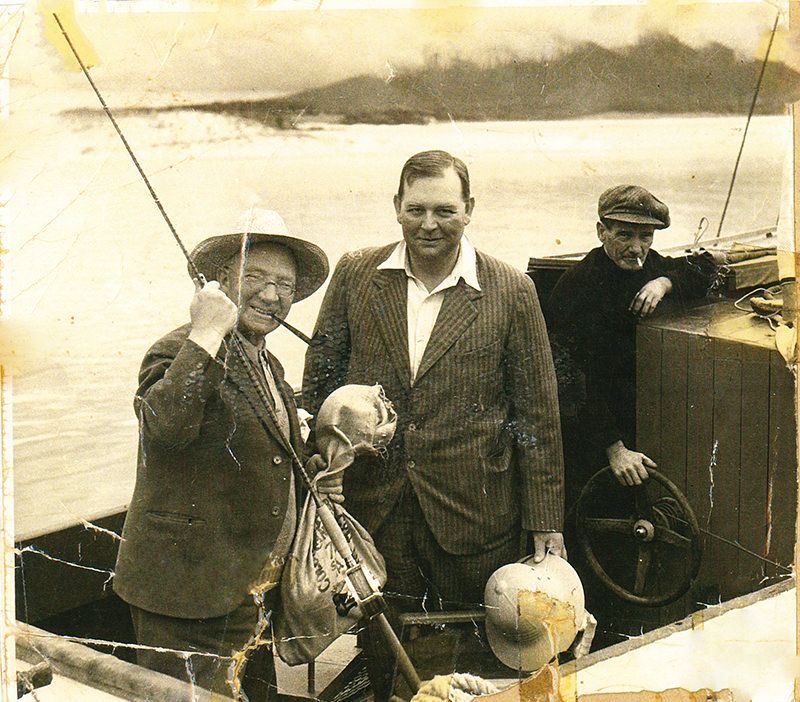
[131,588,278,702]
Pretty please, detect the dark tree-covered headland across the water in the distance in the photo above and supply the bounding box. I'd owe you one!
[67,35,800,128]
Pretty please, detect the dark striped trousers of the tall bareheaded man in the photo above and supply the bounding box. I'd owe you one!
[359,485,520,702]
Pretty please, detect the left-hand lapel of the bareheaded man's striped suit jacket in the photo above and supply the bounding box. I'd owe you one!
[369,270,411,389]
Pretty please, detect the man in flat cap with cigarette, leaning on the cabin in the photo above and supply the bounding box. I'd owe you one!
[546,185,713,505]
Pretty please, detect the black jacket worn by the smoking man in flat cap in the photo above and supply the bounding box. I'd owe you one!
[545,247,714,486]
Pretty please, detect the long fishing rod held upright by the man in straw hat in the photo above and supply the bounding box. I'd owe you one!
[53,12,422,692]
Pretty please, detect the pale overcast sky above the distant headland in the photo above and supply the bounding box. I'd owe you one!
[6,0,792,106]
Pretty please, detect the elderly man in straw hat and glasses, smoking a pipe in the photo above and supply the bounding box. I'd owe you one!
[114,210,335,701]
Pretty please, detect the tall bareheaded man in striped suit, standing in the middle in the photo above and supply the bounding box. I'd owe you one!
[303,151,565,702]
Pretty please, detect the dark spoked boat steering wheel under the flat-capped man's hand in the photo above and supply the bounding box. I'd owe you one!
[575,467,701,607]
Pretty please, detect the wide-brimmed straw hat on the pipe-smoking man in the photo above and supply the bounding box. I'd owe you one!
[189,207,330,302]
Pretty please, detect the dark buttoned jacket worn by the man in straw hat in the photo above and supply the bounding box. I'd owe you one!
[114,325,302,619]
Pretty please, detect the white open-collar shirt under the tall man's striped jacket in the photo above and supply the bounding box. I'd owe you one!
[378,236,481,383]
